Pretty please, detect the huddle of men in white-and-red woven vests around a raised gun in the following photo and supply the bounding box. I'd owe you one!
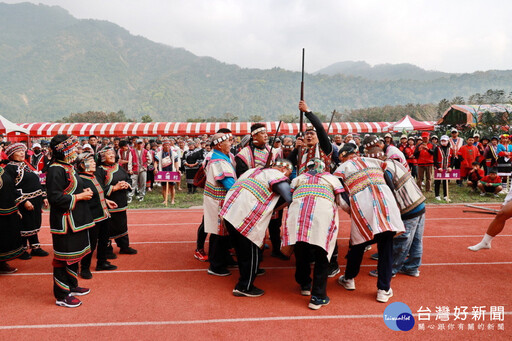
[200,101,425,310]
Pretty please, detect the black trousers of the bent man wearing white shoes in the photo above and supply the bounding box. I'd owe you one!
[345,231,395,291]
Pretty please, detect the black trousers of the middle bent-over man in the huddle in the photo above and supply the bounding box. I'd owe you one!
[294,242,330,298]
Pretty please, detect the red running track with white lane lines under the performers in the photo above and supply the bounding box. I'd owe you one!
[0,205,512,340]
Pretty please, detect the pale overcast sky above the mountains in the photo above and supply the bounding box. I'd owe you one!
[4,0,512,72]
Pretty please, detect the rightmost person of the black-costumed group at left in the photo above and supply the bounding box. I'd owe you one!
[96,147,137,255]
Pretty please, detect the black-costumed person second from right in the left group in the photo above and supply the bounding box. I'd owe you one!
[77,153,118,279]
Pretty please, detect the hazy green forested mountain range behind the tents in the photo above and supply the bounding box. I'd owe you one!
[0,3,512,122]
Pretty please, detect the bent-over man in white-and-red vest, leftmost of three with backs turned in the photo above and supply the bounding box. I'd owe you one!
[220,160,293,297]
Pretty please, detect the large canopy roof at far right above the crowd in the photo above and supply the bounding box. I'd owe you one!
[437,104,512,125]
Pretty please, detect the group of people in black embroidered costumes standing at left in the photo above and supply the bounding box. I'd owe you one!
[0,135,137,308]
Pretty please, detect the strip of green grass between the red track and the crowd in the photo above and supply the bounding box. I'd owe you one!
[128,180,505,208]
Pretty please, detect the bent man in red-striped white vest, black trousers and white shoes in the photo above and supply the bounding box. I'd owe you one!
[334,142,405,302]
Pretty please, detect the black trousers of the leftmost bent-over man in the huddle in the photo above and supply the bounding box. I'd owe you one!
[224,220,261,290]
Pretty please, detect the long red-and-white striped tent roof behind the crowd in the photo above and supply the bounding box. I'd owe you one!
[13,122,436,137]
